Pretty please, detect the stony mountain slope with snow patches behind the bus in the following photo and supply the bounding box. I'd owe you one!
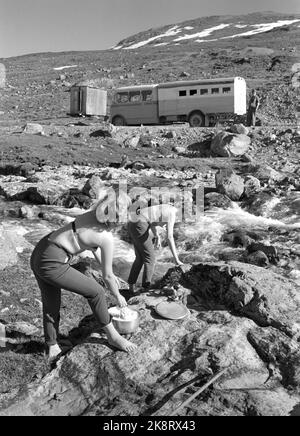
[0,13,300,125]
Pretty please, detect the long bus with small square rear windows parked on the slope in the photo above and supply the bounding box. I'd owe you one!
[110,77,247,127]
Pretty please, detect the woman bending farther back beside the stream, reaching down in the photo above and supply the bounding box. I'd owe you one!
[128,204,183,292]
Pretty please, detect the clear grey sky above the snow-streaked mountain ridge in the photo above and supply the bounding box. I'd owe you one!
[0,0,300,57]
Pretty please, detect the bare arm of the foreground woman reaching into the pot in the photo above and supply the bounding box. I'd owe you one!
[94,234,127,307]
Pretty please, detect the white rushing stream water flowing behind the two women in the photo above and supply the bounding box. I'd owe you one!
[0,192,300,288]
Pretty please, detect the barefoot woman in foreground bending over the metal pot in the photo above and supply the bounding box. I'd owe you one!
[31,192,135,360]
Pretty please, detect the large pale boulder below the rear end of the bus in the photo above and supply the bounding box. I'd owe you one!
[211,132,251,157]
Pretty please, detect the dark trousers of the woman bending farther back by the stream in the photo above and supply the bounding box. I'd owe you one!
[128,220,155,288]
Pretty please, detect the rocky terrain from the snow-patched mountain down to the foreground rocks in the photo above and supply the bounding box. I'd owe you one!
[0,13,300,416]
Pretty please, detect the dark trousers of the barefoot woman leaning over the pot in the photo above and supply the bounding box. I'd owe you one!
[30,235,111,346]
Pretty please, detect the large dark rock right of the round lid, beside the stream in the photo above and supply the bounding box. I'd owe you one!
[180,262,300,337]
